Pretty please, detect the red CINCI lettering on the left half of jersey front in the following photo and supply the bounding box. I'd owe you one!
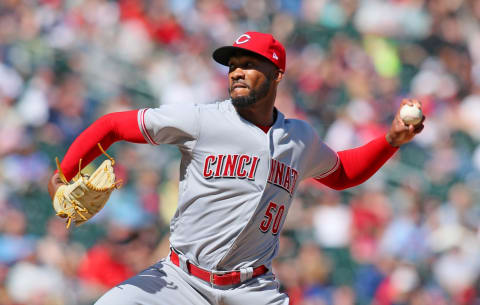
[203,155,259,180]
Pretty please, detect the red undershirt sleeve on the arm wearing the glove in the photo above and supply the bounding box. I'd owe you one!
[60,110,147,181]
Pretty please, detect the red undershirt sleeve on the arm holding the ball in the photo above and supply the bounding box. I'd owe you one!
[315,136,398,190]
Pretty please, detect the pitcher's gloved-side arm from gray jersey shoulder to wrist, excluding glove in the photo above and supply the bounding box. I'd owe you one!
[48,105,199,198]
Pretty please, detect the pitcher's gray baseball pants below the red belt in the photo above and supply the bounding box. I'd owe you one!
[95,258,289,305]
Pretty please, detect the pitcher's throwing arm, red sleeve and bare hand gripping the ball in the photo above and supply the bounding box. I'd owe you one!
[315,100,425,190]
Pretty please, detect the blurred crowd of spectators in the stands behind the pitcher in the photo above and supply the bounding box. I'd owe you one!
[0,0,480,305]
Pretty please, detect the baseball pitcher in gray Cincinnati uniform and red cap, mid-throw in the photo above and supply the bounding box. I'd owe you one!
[49,32,424,305]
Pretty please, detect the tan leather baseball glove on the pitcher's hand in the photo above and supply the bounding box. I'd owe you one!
[53,144,120,228]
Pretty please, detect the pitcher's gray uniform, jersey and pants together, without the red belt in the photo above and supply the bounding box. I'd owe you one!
[95,100,338,305]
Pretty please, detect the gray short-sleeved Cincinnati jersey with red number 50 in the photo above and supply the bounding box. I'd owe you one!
[138,100,339,270]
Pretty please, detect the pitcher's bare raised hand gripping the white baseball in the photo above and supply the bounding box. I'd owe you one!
[386,99,425,147]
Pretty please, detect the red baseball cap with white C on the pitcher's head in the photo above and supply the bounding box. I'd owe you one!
[212,32,286,71]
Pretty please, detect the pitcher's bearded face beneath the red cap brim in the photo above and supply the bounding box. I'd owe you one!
[228,55,276,107]
